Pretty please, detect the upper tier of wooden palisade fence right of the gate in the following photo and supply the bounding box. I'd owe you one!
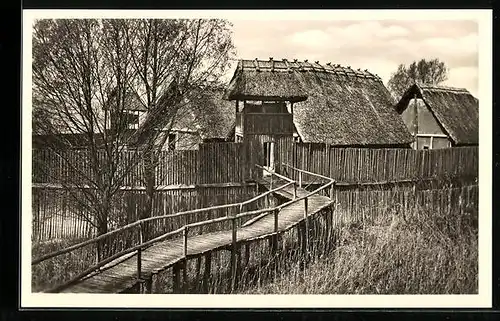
[290,144,479,184]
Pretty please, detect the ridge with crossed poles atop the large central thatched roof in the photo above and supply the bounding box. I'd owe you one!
[238,58,382,81]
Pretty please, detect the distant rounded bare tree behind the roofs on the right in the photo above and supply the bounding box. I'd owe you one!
[387,58,448,99]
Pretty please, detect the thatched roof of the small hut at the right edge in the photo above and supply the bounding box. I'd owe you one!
[396,84,479,145]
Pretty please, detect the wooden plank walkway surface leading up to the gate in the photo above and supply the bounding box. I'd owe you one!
[61,181,332,293]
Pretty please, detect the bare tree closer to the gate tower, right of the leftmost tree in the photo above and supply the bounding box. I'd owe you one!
[127,19,234,238]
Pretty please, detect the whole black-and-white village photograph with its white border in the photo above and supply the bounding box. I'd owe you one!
[21,10,492,307]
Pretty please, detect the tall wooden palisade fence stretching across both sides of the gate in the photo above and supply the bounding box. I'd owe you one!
[32,143,478,243]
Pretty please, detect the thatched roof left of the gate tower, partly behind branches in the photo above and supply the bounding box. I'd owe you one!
[172,89,236,139]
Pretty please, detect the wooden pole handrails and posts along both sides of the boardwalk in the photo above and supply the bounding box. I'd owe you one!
[32,165,335,292]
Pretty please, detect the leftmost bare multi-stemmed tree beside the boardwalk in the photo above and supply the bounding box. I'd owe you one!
[32,19,143,253]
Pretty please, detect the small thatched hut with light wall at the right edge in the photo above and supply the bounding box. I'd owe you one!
[396,84,479,149]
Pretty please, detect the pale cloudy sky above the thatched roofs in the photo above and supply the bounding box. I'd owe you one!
[226,20,478,96]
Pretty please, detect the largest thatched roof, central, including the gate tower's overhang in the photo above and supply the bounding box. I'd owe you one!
[225,59,413,146]
